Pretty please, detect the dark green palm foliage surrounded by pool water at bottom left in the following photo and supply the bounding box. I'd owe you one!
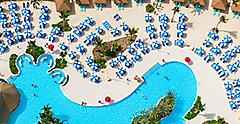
[38,105,64,124]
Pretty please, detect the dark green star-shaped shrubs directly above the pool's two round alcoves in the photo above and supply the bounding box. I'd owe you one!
[26,41,45,62]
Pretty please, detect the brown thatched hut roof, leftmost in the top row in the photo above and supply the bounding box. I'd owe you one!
[55,0,71,12]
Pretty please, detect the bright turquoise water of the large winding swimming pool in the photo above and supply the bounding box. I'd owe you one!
[8,55,197,124]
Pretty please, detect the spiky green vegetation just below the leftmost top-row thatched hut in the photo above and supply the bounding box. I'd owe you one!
[52,11,72,32]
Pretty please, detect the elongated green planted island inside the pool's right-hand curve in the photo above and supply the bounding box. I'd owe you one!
[132,91,175,124]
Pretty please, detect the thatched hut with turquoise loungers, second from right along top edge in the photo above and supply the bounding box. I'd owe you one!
[212,0,227,16]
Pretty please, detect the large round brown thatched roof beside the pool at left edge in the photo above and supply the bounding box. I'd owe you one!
[0,82,19,124]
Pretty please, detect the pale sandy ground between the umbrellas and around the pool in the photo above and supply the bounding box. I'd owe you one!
[0,1,240,124]
